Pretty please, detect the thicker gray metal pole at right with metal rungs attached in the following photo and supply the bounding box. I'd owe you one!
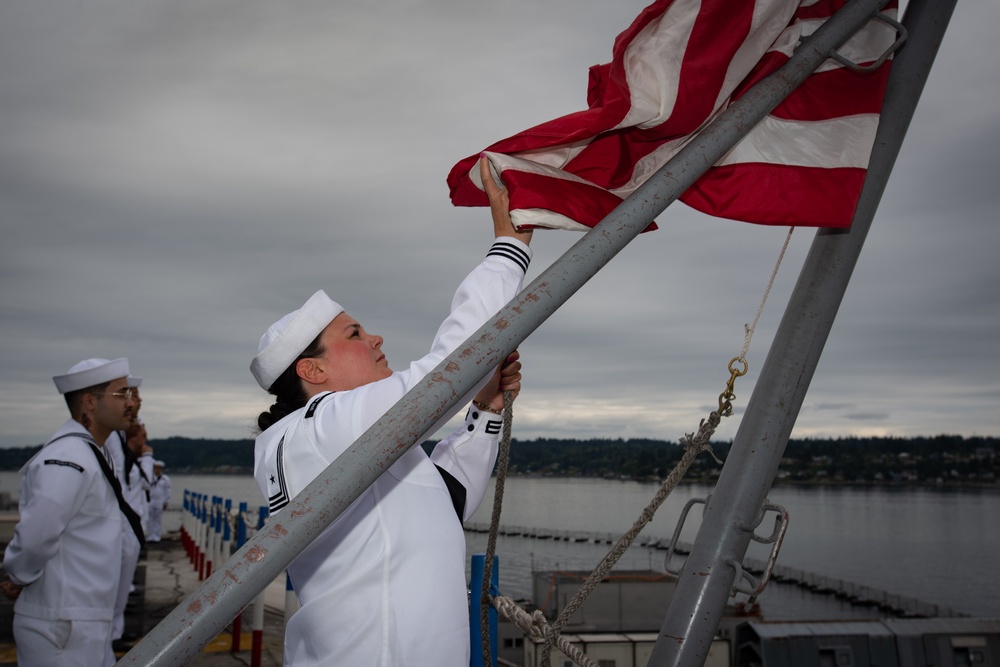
[648,0,957,667]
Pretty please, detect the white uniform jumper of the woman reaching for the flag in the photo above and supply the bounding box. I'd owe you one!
[254,238,531,667]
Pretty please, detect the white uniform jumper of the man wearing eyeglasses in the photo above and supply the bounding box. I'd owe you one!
[4,419,128,667]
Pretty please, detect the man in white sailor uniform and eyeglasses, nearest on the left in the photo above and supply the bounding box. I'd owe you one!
[0,358,138,666]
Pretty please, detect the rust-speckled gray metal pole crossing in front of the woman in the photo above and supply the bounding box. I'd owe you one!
[118,0,887,667]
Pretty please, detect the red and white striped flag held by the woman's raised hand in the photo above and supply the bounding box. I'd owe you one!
[448,0,897,230]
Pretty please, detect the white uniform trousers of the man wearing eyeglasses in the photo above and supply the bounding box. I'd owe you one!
[13,614,115,667]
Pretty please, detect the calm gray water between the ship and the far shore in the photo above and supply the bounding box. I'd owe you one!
[0,472,1000,619]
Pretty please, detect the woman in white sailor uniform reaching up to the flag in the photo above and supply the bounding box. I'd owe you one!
[250,158,531,667]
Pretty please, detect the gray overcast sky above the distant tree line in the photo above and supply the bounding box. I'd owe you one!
[0,0,1000,446]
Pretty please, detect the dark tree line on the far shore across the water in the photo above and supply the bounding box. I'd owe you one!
[0,435,1000,485]
